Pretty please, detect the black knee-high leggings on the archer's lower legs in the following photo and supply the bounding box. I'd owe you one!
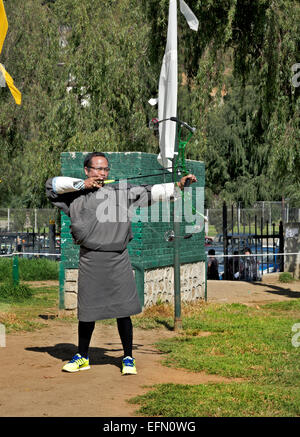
[78,317,133,358]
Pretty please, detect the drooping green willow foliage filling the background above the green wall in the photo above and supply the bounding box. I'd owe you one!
[0,0,300,207]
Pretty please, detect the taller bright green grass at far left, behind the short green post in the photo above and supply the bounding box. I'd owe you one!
[0,258,59,282]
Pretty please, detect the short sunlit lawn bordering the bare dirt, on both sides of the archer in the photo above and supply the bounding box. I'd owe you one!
[0,287,300,417]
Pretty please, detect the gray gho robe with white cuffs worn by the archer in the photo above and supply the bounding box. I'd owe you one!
[46,176,181,322]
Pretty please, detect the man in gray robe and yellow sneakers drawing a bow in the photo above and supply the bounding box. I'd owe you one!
[46,152,197,375]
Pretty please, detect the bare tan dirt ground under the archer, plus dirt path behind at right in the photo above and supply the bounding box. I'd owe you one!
[0,275,300,417]
